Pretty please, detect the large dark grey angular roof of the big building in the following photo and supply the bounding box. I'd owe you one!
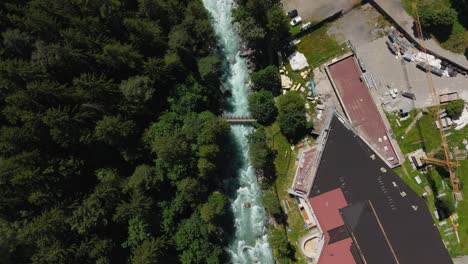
[310,116,452,264]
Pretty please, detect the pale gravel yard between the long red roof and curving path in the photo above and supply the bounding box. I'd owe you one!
[328,5,468,111]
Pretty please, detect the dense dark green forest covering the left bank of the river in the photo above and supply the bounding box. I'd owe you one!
[0,0,233,264]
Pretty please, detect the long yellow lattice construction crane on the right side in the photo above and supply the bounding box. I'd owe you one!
[413,3,463,201]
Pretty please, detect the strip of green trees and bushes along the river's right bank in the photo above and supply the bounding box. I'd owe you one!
[234,0,313,263]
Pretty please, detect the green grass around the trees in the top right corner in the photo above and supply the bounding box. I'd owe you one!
[401,0,468,53]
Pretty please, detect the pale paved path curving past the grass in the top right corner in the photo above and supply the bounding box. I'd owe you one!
[373,0,468,68]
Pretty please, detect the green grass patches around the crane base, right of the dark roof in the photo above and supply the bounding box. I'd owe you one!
[387,108,468,256]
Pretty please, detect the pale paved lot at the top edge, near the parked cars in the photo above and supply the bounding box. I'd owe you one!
[281,0,360,21]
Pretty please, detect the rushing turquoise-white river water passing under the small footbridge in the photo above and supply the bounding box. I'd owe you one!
[203,0,273,264]
